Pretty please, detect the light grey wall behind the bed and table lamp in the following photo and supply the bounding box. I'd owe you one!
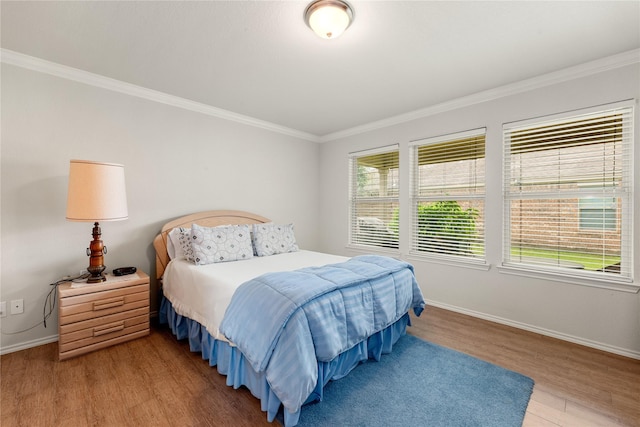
[0,64,320,352]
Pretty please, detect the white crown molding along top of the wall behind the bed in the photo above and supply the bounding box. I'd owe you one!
[0,48,319,142]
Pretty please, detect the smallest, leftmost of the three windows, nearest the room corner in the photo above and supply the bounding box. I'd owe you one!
[349,145,400,249]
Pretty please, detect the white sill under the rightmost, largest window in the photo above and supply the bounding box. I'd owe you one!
[498,264,640,294]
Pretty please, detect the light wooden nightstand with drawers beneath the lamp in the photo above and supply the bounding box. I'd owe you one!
[58,271,149,360]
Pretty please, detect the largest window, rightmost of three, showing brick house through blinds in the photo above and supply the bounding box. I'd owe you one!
[503,105,633,282]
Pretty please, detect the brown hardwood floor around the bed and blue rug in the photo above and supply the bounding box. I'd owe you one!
[0,307,640,427]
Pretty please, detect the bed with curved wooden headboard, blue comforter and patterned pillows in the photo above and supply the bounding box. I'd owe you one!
[154,211,424,427]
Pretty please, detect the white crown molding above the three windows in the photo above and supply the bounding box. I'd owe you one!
[319,49,640,142]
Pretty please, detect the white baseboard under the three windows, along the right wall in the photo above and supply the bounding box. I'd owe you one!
[425,300,640,360]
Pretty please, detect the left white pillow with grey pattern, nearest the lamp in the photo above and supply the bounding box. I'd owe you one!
[191,224,253,265]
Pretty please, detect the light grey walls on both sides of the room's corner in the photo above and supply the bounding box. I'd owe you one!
[0,56,640,357]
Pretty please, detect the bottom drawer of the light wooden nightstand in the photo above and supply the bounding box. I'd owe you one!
[58,313,149,353]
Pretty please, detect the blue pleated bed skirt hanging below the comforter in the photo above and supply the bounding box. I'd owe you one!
[159,297,411,427]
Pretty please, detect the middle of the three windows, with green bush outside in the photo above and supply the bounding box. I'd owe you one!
[410,128,485,261]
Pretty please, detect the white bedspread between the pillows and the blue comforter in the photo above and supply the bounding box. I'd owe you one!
[162,250,348,341]
